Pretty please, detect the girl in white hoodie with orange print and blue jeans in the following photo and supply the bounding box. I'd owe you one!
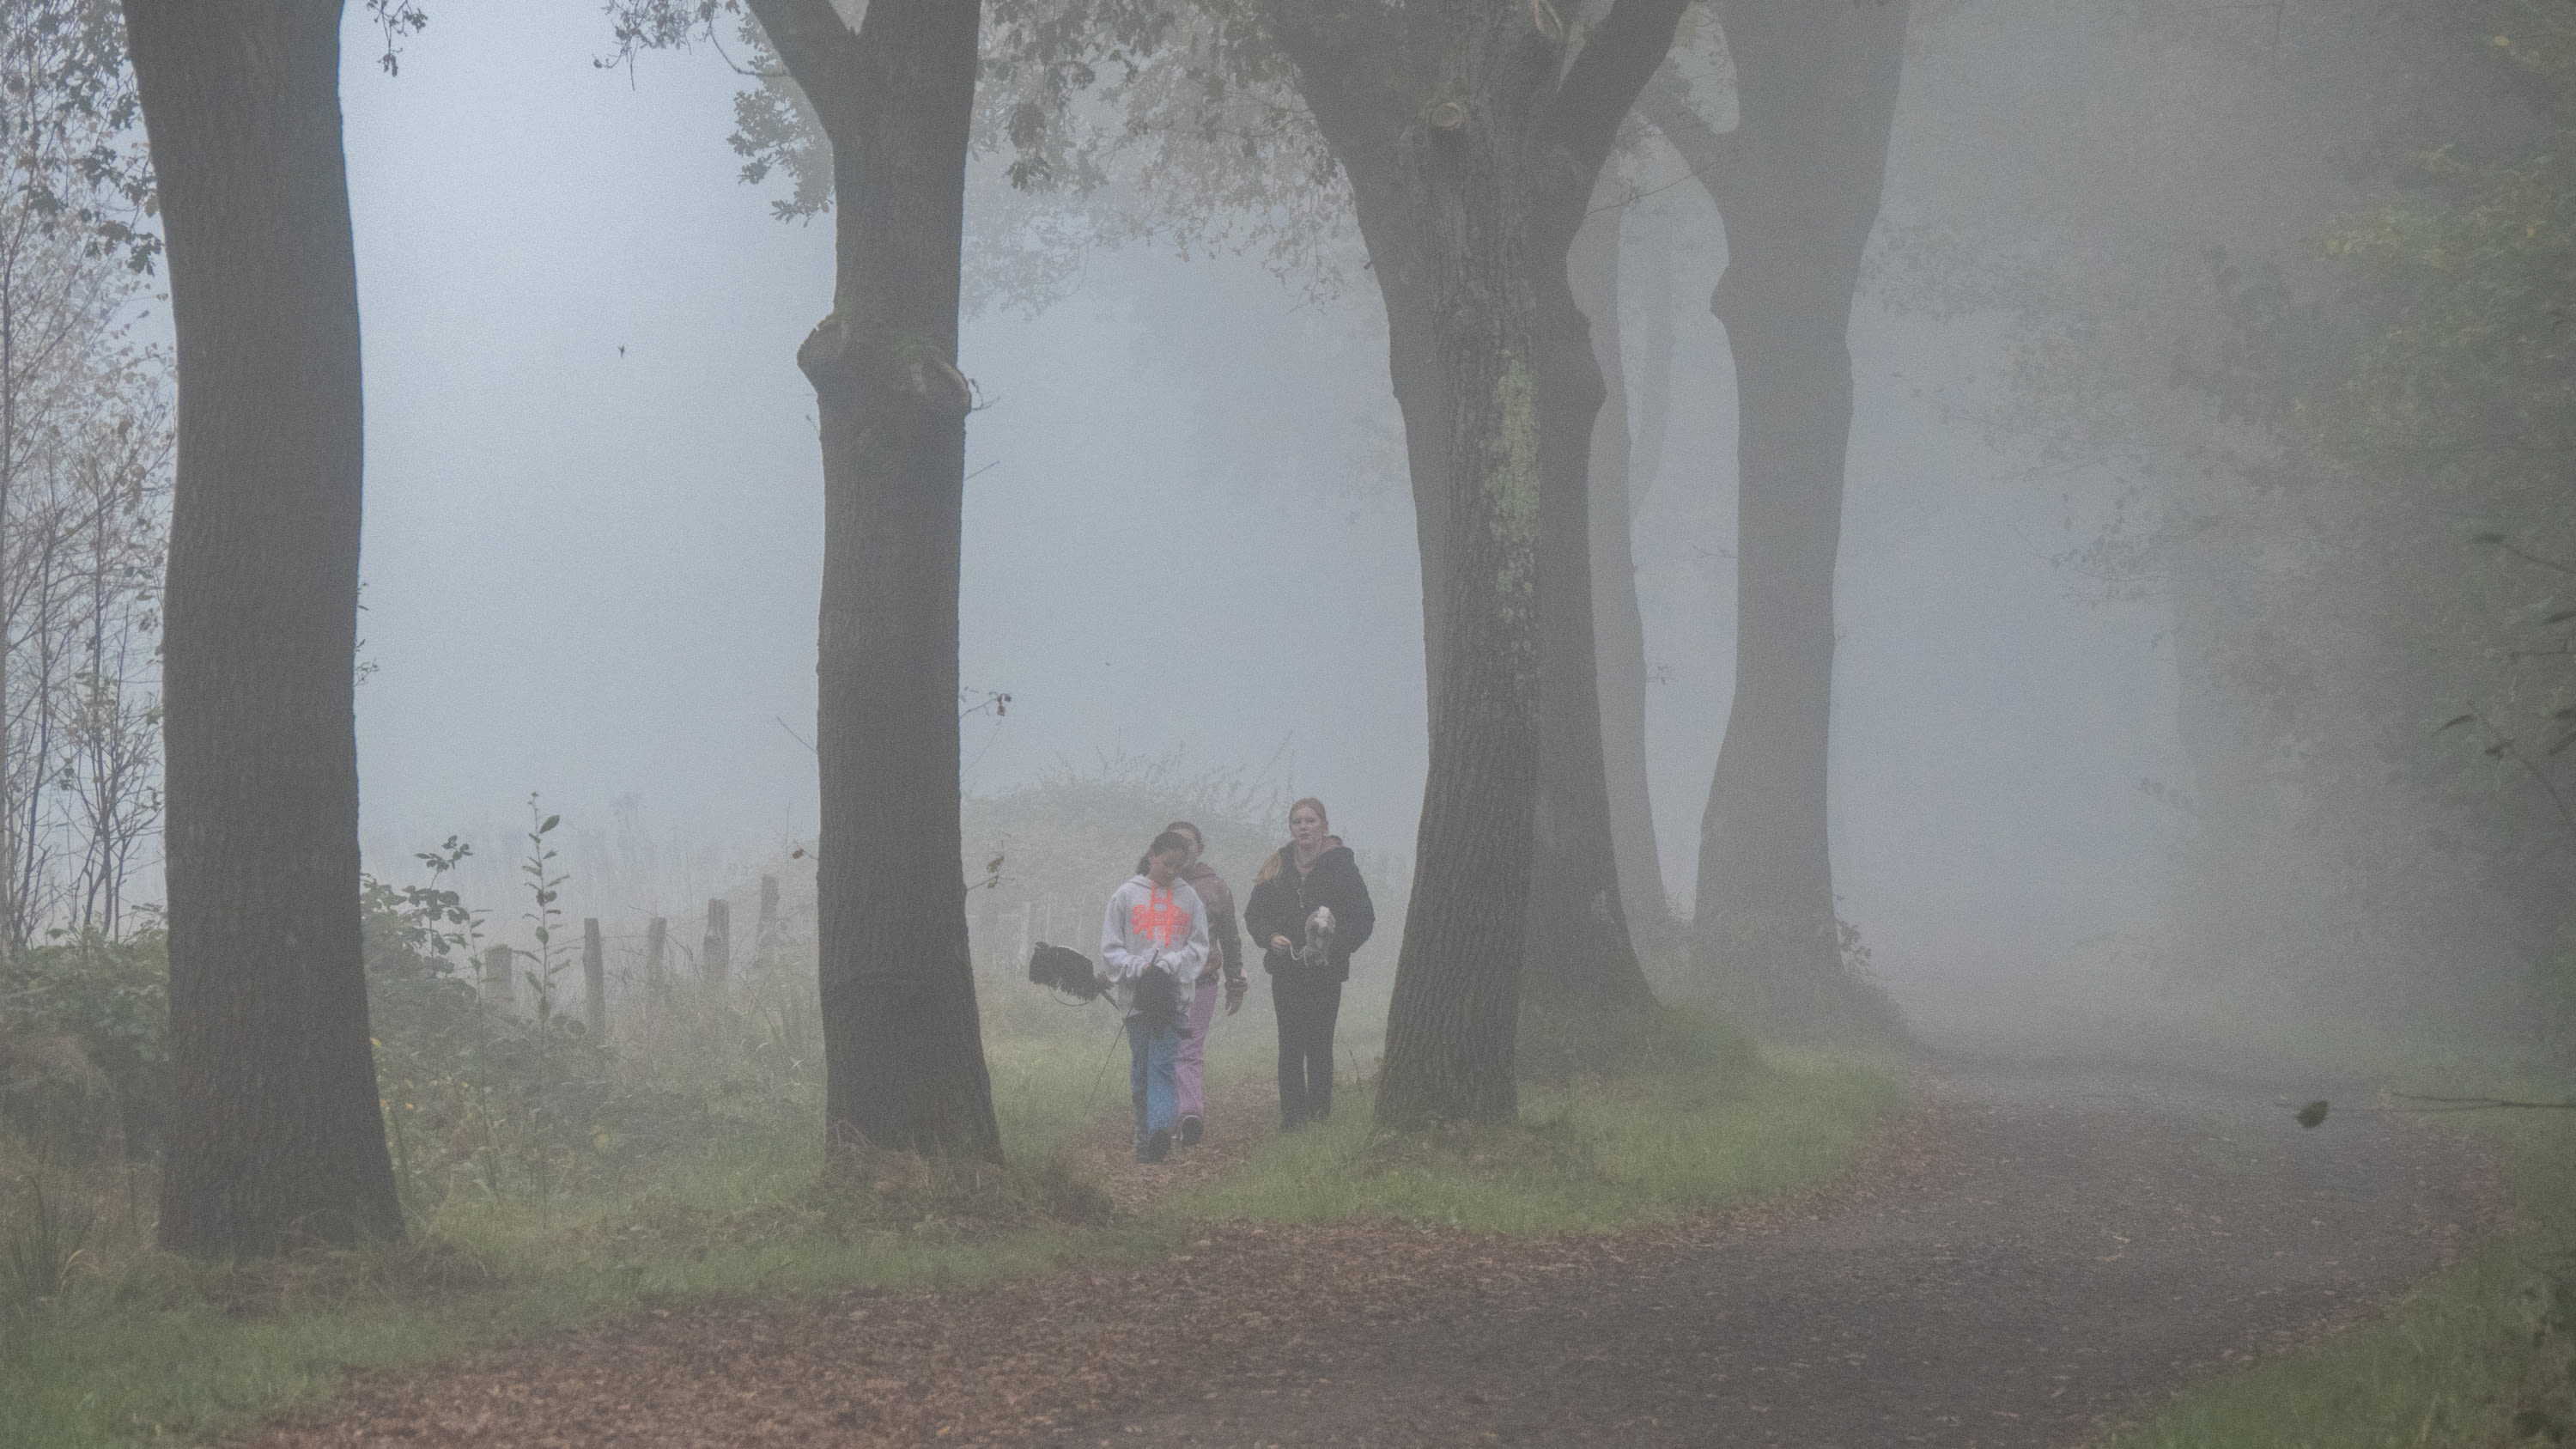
[1100,831,1208,1163]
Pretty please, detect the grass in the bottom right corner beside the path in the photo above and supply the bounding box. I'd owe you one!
[2099,1088,2576,1449]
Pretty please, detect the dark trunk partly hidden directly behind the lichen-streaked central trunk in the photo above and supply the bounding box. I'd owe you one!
[1520,171,1654,1075]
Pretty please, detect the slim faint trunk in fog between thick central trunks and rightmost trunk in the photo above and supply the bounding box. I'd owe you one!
[1566,206,1672,931]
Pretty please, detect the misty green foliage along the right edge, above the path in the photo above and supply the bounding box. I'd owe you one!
[2169,0,2576,1055]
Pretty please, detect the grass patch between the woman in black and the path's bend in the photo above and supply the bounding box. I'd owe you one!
[1167,1008,1901,1233]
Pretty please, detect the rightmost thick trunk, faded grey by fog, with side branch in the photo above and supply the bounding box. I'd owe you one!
[1646,0,1906,1021]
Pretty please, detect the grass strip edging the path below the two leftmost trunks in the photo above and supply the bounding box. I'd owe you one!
[0,1039,1170,1449]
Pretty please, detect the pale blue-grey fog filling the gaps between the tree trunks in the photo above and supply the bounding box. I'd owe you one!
[327,5,2277,1020]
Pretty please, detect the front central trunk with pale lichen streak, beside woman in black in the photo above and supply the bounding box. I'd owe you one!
[1378,33,1556,1124]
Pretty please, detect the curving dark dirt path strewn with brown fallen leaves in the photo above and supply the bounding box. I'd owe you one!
[258,1060,2499,1449]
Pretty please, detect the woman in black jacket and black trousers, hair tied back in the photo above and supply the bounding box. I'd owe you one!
[1244,797,1378,1132]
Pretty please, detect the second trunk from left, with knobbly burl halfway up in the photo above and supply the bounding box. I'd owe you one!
[752,0,1002,1158]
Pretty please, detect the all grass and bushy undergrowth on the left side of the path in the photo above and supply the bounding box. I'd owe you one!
[0,776,1896,1449]
